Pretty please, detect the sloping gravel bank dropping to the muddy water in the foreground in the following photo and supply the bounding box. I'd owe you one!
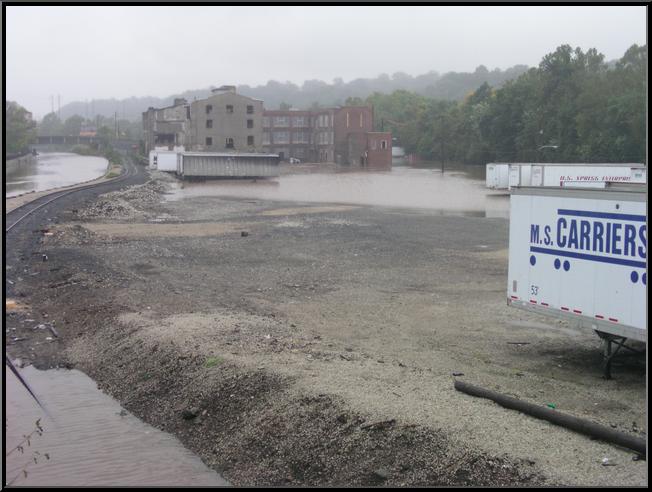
[69,314,543,486]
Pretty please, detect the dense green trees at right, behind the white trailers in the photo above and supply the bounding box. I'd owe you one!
[366,45,647,164]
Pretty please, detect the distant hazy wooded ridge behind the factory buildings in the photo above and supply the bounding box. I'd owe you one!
[53,65,528,120]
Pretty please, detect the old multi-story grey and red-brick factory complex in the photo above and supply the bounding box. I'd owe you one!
[143,85,392,168]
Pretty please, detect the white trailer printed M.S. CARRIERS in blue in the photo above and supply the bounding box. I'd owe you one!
[507,185,647,378]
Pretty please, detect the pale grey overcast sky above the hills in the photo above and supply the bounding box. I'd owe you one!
[5,6,647,118]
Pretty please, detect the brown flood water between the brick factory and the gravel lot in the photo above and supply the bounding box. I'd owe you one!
[168,162,509,218]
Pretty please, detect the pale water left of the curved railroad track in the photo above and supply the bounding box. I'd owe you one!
[5,152,108,197]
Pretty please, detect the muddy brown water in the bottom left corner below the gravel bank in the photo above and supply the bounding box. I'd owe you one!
[5,366,228,486]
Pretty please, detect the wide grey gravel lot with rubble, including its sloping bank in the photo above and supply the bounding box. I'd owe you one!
[7,169,646,485]
